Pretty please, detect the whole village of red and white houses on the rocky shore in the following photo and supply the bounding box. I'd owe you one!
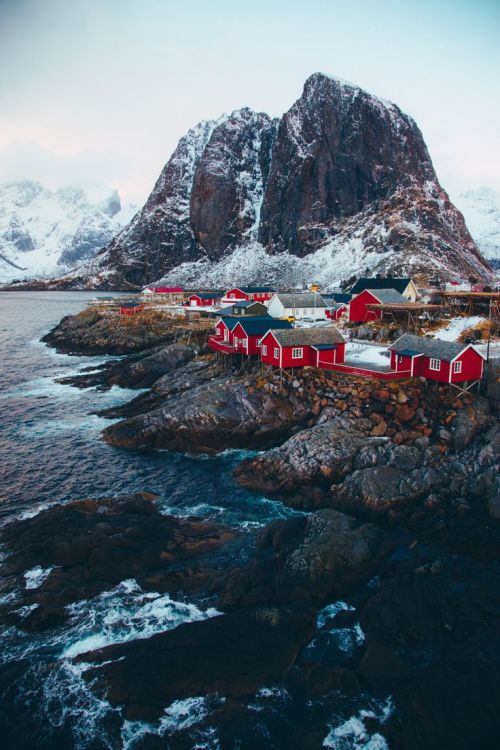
[105,277,500,390]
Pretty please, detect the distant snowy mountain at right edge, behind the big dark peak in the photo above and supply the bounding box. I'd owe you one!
[455,187,500,269]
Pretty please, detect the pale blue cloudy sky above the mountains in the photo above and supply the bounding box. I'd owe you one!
[0,0,500,201]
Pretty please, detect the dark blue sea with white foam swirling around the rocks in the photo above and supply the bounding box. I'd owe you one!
[0,292,389,750]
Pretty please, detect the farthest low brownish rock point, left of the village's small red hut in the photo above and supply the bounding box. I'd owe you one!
[42,310,174,355]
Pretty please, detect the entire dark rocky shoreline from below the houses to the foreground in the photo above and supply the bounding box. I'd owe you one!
[13,308,500,750]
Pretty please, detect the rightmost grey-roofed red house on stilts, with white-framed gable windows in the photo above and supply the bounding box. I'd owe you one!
[389,333,484,383]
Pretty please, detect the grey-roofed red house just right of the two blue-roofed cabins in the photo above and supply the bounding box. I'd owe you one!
[260,328,345,368]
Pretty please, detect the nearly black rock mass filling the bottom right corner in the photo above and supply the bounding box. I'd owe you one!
[359,550,500,750]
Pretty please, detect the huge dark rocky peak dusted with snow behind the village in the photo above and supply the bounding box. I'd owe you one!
[67,73,491,288]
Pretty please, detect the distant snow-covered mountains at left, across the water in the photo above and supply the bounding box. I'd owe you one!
[0,180,137,282]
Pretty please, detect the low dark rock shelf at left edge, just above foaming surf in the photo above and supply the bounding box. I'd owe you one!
[0,493,237,630]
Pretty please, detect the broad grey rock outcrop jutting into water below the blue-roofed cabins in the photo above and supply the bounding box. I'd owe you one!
[103,378,309,453]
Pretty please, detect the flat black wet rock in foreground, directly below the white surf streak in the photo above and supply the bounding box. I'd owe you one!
[77,607,314,720]
